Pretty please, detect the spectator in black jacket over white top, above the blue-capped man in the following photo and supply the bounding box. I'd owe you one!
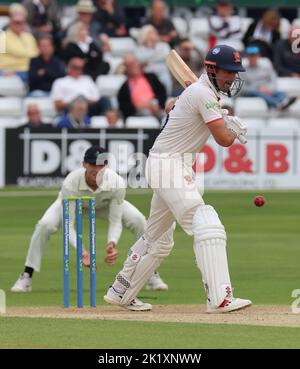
[243,9,280,60]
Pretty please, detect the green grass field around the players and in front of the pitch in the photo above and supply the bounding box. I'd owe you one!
[0,189,300,348]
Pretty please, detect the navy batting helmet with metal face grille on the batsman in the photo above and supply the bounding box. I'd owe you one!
[204,45,246,97]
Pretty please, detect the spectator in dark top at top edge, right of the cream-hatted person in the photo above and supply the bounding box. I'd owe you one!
[93,0,127,37]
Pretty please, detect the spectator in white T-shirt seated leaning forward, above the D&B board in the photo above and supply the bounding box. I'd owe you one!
[51,57,118,120]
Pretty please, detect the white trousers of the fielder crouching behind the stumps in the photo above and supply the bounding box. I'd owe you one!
[25,197,146,272]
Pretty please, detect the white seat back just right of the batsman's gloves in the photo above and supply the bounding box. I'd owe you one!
[235,97,269,118]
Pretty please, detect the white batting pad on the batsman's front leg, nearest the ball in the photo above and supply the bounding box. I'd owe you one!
[193,205,232,306]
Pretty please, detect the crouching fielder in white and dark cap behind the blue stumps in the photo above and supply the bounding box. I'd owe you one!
[11,146,173,304]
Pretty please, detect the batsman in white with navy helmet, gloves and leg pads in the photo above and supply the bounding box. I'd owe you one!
[104,45,251,313]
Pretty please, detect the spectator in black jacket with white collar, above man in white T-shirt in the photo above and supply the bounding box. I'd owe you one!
[63,22,110,80]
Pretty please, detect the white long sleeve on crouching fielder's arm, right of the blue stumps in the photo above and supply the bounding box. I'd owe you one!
[107,189,125,244]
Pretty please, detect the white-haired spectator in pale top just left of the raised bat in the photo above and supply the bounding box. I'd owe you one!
[135,24,172,95]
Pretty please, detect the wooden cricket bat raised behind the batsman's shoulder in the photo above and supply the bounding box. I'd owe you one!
[166,50,198,88]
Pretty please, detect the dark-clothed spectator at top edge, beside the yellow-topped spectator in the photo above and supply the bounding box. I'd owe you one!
[23,0,61,37]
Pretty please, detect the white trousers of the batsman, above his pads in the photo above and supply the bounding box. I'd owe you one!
[145,153,204,244]
